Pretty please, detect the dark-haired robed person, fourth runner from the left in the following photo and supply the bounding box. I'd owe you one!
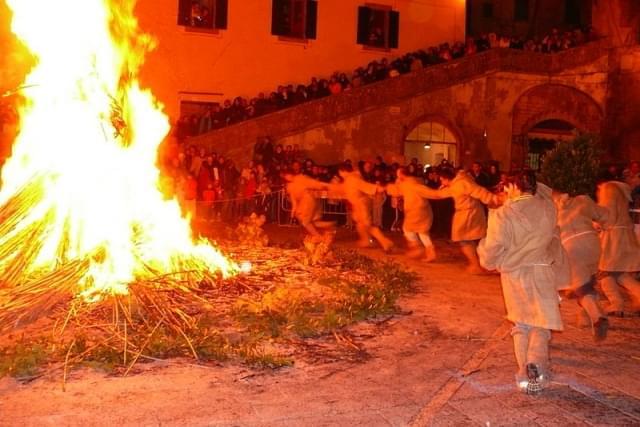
[432,166,500,274]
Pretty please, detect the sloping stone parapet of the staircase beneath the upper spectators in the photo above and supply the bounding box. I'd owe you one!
[189,40,609,161]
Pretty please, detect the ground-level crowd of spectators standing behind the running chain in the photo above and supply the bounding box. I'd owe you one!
[162,139,506,233]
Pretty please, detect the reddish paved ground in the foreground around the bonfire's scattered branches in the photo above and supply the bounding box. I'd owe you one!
[0,231,640,426]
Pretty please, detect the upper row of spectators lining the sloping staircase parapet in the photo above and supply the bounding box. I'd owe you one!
[176,29,594,141]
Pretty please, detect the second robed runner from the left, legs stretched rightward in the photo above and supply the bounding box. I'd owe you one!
[332,164,393,252]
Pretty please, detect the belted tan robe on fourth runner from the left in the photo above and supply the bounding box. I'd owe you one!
[432,171,498,242]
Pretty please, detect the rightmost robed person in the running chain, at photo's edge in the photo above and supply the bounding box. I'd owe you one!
[597,181,640,317]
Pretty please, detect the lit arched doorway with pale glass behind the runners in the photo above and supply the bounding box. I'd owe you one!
[404,120,459,168]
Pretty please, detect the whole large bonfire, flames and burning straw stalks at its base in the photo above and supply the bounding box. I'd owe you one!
[0,0,237,330]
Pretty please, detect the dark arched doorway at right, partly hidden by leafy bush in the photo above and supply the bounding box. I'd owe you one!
[525,119,576,171]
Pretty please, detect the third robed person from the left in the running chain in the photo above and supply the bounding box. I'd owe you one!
[385,167,437,262]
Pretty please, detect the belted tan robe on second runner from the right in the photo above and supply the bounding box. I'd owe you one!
[553,194,608,289]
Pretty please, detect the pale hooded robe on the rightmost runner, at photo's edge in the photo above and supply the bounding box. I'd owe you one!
[598,181,640,272]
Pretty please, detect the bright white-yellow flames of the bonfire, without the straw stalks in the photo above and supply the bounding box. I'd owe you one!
[0,0,238,299]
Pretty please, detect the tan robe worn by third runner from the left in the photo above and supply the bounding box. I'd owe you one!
[386,177,437,233]
